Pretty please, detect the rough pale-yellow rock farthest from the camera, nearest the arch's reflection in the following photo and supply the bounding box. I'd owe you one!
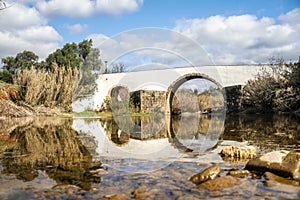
[221,146,256,159]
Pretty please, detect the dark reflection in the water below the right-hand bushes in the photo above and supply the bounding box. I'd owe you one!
[223,115,300,151]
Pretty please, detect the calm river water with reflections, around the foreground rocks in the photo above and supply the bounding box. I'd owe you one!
[0,114,300,199]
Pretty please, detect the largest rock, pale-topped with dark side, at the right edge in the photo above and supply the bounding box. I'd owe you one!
[245,151,300,179]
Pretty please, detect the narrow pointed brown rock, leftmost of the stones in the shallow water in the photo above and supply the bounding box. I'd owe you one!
[190,166,221,184]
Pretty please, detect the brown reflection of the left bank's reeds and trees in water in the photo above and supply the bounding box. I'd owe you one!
[0,120,101,190]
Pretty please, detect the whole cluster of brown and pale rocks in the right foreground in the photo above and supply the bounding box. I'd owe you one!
[189,146,300,190]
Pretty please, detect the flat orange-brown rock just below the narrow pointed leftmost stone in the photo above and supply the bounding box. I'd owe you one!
[199,176,240,190]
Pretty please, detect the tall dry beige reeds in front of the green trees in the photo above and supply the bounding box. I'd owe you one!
[14,63,79,111]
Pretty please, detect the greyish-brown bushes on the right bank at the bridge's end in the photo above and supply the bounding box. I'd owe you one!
[241,57,300,113]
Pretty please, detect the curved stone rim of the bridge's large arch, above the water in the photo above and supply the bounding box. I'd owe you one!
[166,73,225,115]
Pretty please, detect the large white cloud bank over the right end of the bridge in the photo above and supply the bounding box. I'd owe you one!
[174,9,300,64]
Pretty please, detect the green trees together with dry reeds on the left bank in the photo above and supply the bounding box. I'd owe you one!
[0,40,103,115]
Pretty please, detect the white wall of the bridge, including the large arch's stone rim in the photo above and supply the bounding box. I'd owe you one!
[73,65,261,113]
